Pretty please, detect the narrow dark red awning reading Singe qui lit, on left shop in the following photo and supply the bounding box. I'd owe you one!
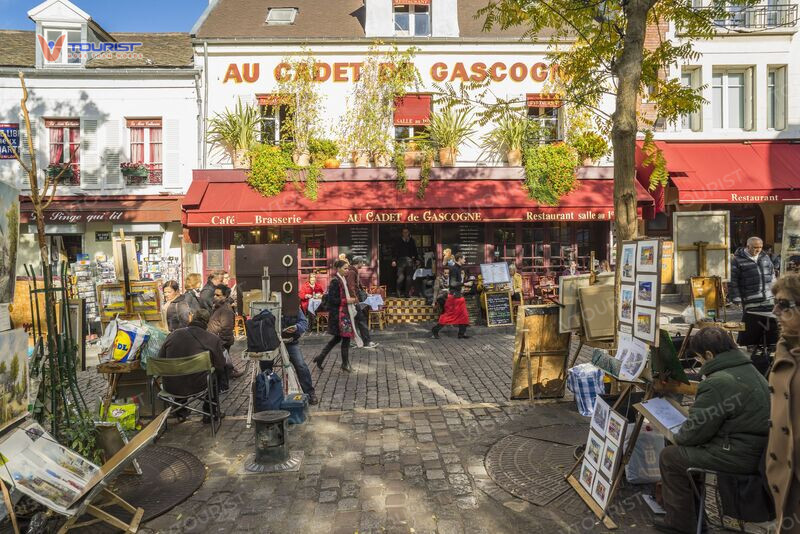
[20,195,182,224]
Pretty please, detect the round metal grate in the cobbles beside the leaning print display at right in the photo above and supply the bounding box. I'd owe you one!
[486,435,575,506]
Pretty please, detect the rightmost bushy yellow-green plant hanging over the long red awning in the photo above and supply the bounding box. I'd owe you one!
[523,143,578,205]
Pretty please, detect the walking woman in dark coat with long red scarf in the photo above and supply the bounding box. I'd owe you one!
[313,260,364,373]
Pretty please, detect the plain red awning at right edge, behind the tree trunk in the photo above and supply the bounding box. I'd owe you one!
[639,141,800,204]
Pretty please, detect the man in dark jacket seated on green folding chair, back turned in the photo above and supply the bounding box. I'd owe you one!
[158,310,225,423]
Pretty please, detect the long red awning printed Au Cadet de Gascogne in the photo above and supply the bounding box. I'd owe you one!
[183,168,653,227]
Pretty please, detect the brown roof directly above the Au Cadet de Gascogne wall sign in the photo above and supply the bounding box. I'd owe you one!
[195,0,536,41]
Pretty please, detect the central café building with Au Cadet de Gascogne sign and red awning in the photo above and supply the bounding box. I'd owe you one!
[188,0,652,294]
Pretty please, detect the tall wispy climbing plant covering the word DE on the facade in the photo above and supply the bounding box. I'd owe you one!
[341,42,420,156]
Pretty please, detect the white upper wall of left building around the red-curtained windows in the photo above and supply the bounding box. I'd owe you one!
[0,69,198,195]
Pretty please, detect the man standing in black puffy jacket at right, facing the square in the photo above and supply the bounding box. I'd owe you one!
[728,237,778,346]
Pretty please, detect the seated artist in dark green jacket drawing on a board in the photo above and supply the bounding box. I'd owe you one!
[654,326,770,533]
